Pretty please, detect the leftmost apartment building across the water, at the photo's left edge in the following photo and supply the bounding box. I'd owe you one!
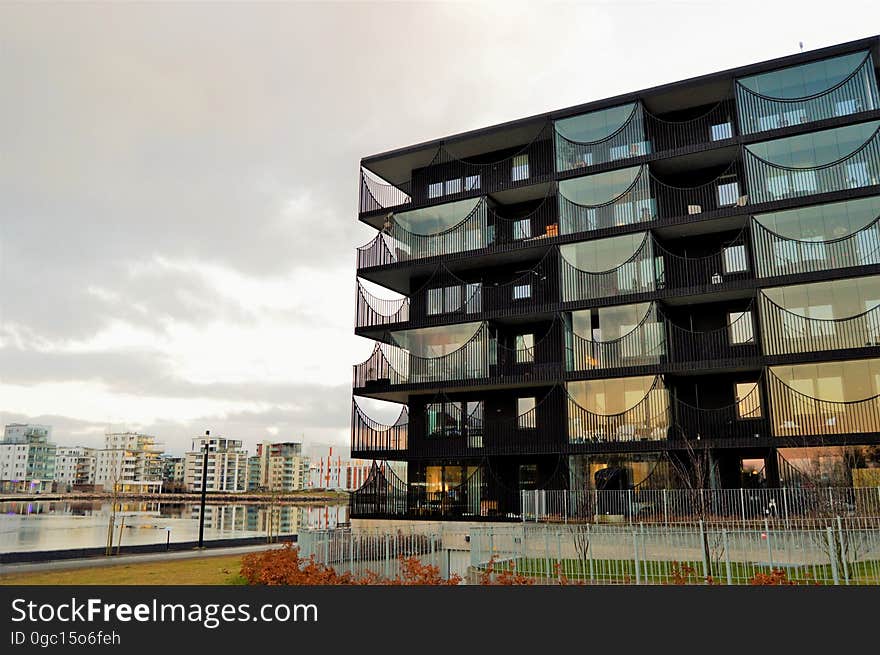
[0,423,56,493]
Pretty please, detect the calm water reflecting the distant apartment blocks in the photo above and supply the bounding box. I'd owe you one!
[0,501,348,553]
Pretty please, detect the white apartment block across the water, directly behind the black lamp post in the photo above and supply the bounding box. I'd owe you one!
[184,433,248,492]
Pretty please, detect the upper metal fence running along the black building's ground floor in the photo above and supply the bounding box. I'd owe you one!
[521,487,880,525]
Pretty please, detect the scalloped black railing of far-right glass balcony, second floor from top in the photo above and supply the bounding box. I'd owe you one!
[744,121,880,203]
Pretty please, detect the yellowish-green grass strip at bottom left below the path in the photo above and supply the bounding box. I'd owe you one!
[0,555,248,585]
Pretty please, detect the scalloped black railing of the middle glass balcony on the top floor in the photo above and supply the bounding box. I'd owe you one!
[554,102,651,173]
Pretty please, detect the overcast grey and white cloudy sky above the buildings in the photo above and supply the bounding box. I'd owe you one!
[0,0,880,452]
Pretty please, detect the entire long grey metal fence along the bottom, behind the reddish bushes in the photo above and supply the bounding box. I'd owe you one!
[298,517,880,585]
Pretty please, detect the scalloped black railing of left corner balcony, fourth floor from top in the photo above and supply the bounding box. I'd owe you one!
[353,323,491,390]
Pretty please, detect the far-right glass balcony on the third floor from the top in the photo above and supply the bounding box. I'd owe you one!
[751,196,880,278]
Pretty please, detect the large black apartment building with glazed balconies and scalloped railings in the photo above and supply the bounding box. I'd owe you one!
[351,37,880,520]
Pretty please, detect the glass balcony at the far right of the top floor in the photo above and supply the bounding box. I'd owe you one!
[736,52,880,134]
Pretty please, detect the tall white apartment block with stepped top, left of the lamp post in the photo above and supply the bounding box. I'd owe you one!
[94,432,162,493]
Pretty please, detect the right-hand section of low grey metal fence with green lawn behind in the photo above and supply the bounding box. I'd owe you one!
[470,518,880,585]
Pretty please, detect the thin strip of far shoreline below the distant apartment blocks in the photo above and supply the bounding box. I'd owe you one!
[0,491,350,505]
